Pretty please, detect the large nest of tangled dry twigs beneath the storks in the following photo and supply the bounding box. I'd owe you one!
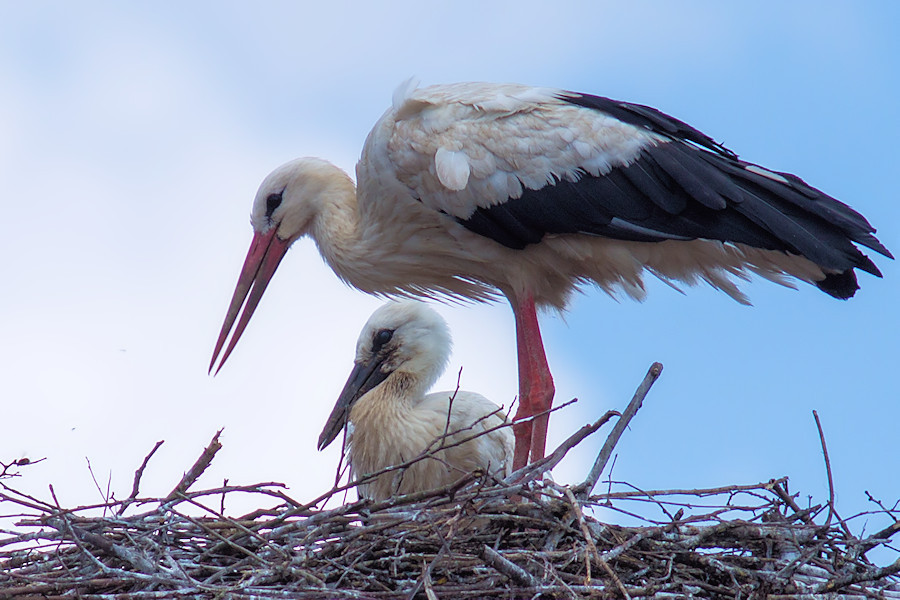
[0,369,900,600]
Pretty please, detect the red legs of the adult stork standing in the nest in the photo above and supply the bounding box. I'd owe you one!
[510,294,555,469]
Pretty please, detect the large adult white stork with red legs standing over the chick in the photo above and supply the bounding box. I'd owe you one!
[210,83,891,468]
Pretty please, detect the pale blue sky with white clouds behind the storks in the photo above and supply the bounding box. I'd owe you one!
[0,0,900,564]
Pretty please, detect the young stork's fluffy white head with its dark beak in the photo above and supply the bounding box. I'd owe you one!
[319,300,451,450]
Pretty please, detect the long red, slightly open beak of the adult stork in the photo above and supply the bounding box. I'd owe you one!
[209,227,291,373]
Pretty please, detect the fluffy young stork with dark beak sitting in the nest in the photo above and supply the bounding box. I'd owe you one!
[319,300,513,501]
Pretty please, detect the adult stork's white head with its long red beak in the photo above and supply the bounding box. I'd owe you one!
[209,158,353,372]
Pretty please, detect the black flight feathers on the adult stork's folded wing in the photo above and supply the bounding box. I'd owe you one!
[459,95,892,298]
